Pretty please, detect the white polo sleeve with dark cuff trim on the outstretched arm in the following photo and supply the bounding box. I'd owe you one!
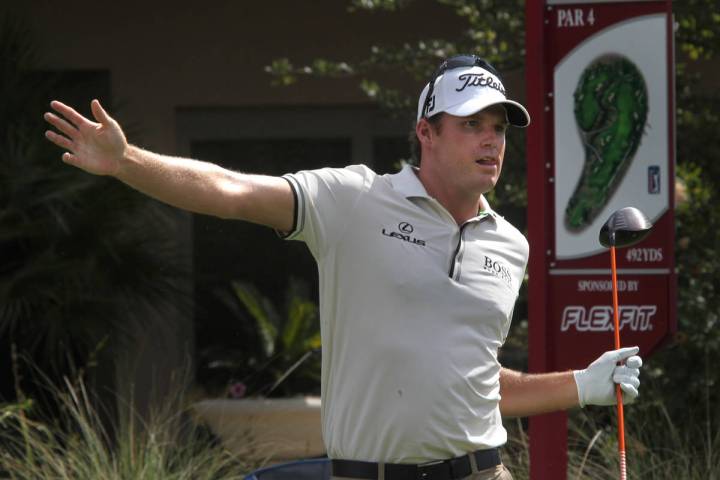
[280,165,376,259]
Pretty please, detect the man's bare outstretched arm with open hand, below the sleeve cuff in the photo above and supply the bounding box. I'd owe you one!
[45,100,294,231]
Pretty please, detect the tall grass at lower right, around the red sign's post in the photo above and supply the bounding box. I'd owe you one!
[503,402,720,480]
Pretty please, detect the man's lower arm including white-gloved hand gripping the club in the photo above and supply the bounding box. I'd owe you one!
[500,347,642,417]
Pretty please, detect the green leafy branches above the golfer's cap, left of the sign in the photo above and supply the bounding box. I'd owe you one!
[266,0,525,110]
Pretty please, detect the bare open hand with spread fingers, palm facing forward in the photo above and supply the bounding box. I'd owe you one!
[44,100,128,175]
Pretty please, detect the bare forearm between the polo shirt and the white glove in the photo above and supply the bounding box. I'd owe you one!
[500,368,579,417]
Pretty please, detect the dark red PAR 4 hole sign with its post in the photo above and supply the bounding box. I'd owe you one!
[526,0,676,480]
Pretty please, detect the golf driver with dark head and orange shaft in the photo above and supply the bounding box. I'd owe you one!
[600,207,652,480]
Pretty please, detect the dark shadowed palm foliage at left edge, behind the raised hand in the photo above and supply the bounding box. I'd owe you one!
[0,16,188,395]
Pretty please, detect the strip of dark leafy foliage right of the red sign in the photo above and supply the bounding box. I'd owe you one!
[645,0,720,430]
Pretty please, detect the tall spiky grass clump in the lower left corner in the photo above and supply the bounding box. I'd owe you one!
[0,379,248,480]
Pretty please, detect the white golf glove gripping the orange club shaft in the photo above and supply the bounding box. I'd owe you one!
[573,347,642,407]
